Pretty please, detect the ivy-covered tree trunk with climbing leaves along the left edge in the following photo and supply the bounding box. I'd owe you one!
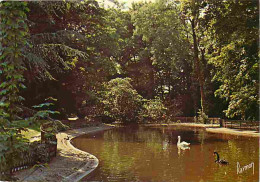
[0,2,28,172]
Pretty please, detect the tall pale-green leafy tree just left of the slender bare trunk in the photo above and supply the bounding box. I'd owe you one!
[131,1,194,115]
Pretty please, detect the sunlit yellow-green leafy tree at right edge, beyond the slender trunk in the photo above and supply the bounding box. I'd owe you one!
[205,0,259,120]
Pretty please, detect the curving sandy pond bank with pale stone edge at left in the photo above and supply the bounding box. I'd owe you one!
[15,124,112,182]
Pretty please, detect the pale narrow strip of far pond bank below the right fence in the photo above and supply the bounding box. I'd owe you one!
[144,123,260,137]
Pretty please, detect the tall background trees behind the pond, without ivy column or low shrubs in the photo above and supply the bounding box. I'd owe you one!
[1,0,258,119]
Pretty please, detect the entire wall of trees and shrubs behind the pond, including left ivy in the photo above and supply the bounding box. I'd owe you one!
[0,0,259,176]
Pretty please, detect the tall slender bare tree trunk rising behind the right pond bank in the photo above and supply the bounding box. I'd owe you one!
[191,18,205,113]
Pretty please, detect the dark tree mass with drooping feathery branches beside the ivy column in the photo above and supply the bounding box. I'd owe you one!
[20,1,117,115]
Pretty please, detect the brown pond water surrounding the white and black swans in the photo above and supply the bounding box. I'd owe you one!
[73,126,259,182]
